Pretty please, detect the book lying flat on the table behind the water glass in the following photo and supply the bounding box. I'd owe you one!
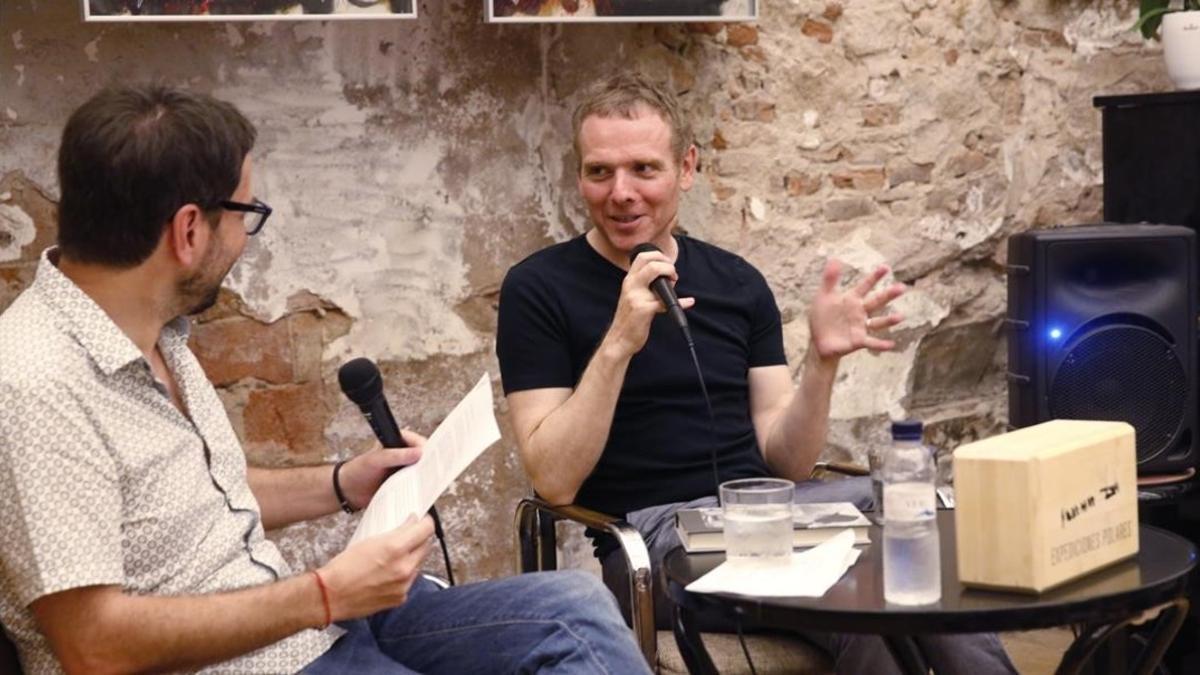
[676,502,871,554]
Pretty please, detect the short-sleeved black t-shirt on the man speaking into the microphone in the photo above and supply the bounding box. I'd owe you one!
[496,237,786,515]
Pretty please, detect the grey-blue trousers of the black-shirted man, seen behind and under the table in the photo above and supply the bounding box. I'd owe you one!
[601,477,1016,675]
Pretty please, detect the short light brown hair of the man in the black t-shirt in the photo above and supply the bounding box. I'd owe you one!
[571,73,692,168]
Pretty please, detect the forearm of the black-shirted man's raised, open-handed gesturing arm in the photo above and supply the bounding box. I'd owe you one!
[764,347,838,480]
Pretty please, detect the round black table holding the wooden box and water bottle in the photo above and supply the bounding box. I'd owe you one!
[662,510,1196,674]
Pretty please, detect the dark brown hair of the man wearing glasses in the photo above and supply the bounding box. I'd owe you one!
[59,84,256,268]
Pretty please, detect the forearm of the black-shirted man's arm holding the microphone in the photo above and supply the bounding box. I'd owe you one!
[524,342,631,503]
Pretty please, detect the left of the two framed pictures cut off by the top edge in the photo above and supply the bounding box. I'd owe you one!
[82,0,416,22]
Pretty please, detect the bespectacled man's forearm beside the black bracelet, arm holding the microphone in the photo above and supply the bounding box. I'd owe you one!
[246,464,338,530]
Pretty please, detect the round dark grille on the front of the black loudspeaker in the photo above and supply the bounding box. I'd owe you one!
[1050,324,1188,462]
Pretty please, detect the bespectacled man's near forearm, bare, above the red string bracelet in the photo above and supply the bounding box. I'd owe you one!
[34,574,325,673]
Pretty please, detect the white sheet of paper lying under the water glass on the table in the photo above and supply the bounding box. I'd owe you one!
[688,530,862,598]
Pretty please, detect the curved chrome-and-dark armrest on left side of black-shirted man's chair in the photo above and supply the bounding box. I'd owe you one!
[516,497,658,670]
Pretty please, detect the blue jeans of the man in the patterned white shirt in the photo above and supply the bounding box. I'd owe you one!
[304,572,649,675]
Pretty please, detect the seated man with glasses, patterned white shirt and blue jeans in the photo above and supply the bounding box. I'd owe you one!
[0,86,647,674]
